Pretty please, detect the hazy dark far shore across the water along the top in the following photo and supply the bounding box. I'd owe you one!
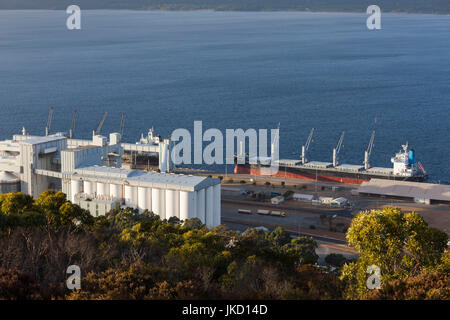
[0,0,450,13]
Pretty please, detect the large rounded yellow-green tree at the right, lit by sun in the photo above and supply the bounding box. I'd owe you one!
[341,208,447,298]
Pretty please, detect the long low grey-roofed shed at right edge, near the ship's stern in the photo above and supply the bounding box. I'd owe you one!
[357,179,450,204]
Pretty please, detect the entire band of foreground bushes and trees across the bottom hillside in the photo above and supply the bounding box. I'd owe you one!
[0,191,450,299]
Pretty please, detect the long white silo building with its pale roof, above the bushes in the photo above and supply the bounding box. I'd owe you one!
[64,166,221,227]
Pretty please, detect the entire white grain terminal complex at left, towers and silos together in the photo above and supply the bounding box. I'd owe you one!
[0,129,221,227]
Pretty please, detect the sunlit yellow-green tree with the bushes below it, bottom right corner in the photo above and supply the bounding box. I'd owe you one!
[341,208,450,299]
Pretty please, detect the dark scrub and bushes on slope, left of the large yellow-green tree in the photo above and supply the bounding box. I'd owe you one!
[0,191,339,299]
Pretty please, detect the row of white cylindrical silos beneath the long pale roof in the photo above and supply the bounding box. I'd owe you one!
[71,180,221,227]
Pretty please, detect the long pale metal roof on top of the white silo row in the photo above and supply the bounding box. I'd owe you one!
[71,166,220,191]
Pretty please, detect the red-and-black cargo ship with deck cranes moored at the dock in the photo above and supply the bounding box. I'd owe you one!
[234,129,427,184]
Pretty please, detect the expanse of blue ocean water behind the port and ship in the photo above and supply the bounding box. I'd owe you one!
[0,11,450,183]
